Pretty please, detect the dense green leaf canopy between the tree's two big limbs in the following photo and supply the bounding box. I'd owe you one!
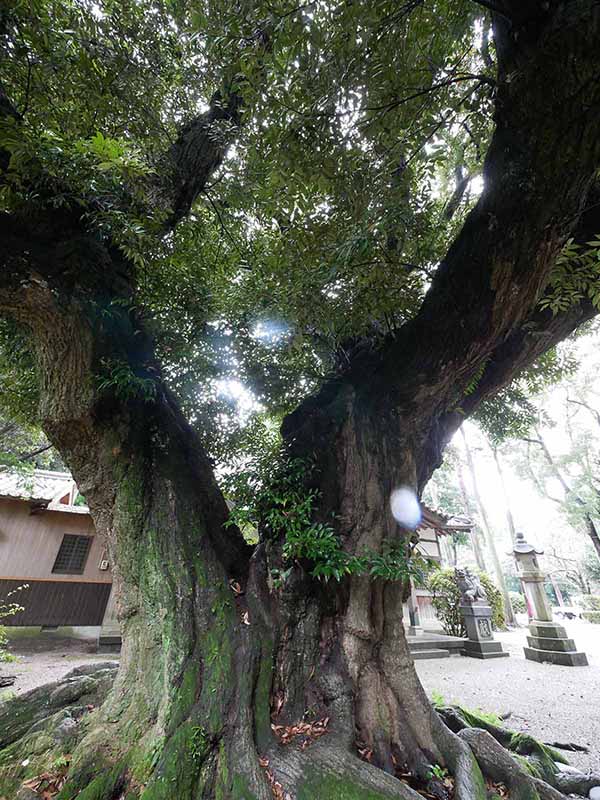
[0,0,502,457]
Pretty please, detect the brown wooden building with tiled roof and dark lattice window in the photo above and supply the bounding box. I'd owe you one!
[0,470,112,637]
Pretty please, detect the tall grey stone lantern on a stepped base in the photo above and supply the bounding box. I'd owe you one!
[513,533,588,667]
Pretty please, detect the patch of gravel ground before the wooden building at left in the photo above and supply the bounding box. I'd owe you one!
[0,636,118,699]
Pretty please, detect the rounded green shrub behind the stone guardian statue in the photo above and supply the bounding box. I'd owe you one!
[427,569,506,636]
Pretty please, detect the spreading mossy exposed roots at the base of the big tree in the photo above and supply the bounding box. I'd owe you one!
[0,663,600,800]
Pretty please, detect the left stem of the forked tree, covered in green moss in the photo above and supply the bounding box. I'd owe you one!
[9,276,280,798]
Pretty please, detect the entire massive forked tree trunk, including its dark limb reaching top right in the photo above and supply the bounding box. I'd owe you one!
[0,2,600,800]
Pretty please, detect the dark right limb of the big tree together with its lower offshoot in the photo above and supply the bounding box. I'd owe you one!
[284,0,600,486]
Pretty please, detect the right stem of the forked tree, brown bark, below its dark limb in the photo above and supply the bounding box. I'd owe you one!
[275,384,492,797]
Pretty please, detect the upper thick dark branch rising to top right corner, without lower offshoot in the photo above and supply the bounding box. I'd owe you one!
[366,2,600,404]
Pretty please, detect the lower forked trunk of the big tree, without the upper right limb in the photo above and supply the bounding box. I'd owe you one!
[2,284,483,800]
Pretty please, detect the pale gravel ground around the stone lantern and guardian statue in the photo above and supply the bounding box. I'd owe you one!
[415,621,600,771]
